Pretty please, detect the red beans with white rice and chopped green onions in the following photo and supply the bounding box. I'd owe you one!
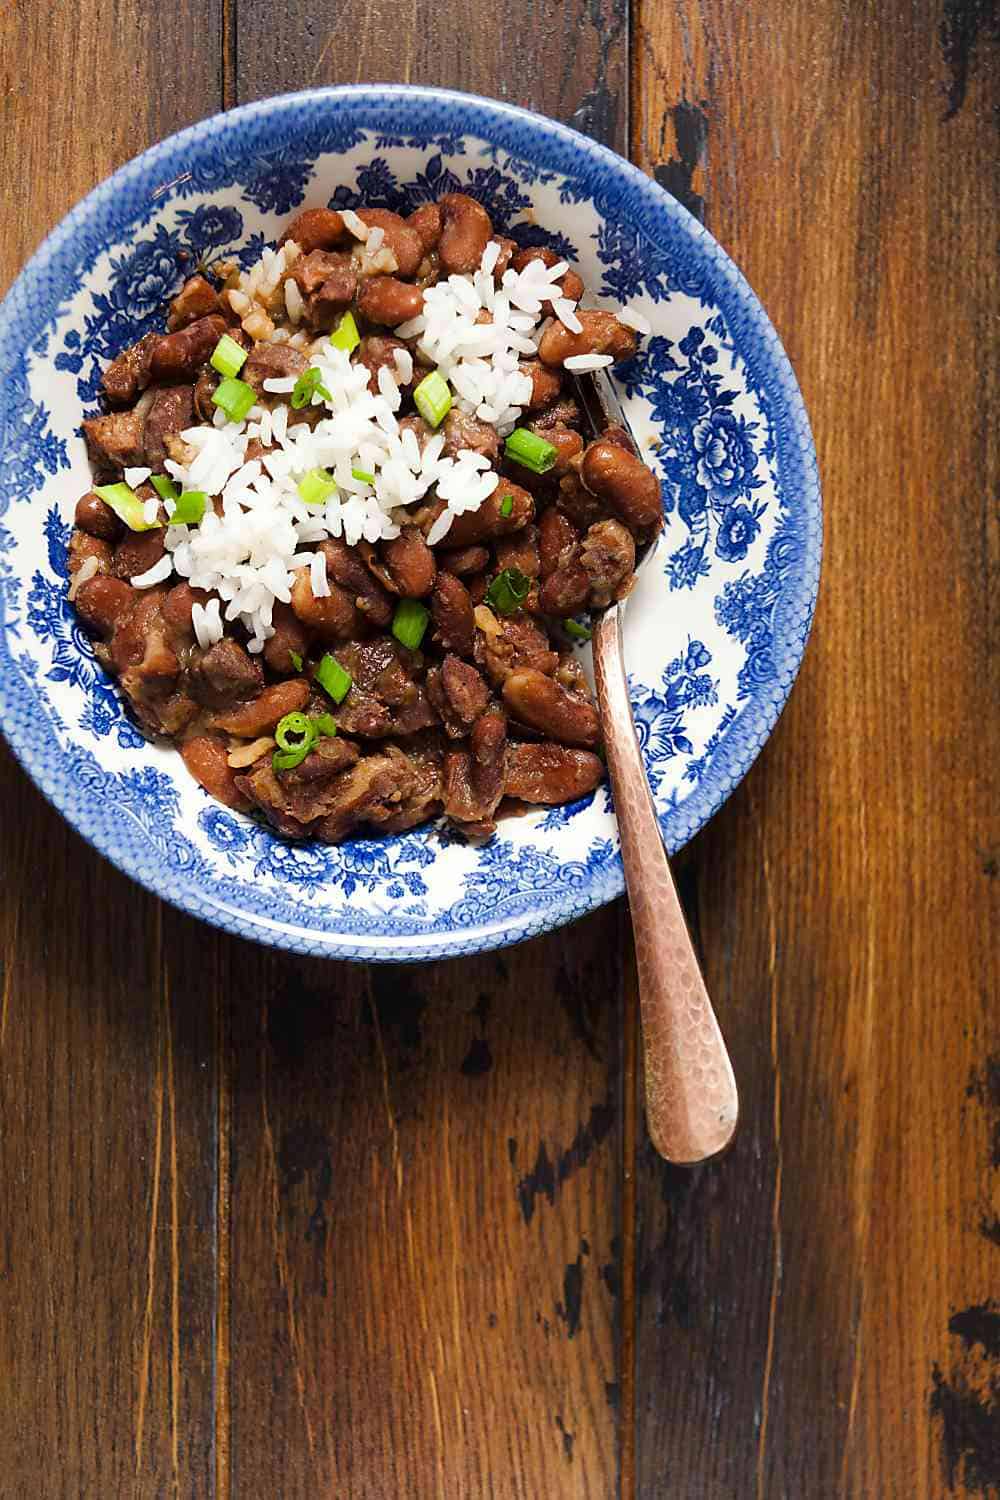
[69,194,661,843]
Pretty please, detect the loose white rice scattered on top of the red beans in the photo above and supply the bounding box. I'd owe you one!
[134,234,639,654]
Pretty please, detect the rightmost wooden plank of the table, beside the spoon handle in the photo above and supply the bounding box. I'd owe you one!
[633,0,1000,1500]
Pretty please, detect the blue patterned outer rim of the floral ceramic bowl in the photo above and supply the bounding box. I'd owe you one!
[0,83,823,963]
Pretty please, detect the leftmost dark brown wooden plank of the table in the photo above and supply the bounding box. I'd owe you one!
[0,0,219,1500]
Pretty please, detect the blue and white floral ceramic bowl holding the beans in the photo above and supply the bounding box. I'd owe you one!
[0,86,822,960]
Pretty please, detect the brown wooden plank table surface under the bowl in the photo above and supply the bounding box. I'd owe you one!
[0,0,1000,1500]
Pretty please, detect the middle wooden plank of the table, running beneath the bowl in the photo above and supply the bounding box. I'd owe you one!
[231,0,627,1500]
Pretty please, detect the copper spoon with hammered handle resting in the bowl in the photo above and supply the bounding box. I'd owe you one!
[577,371,739,1166]
